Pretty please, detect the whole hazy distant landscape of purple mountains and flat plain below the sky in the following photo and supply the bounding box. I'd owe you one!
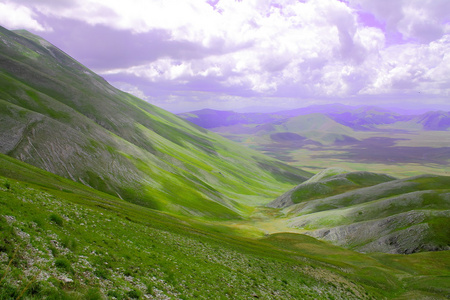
[181,105,450,177]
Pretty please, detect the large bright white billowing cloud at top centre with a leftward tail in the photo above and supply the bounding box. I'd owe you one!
[101,0,356,92]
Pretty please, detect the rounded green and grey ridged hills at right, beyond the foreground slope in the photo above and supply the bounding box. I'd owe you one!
[276,169,450,253]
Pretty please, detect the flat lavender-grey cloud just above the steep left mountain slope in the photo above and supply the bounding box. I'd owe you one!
[36,18,229,70]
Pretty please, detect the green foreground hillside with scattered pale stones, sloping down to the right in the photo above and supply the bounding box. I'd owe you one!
[0,155,450,299]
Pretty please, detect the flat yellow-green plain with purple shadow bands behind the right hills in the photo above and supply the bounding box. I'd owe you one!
[284,131,450,177]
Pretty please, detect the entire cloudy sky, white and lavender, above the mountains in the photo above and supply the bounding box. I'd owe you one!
[0,0,450,112]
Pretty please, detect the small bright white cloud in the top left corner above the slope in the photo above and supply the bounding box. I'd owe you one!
[0,2,51,31]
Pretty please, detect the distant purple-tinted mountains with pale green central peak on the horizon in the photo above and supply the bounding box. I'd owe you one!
[180,104,405,144]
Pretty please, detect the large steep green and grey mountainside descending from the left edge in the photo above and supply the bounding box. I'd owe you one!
[0,28,310,218]
